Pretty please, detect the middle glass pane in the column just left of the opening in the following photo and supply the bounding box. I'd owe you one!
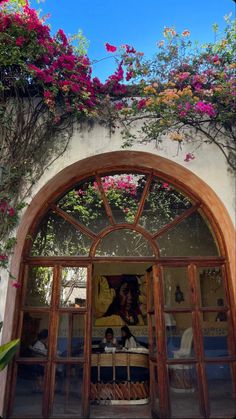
[57,313,85,357]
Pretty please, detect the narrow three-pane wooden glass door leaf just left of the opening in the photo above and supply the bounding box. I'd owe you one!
[55,266,92,417]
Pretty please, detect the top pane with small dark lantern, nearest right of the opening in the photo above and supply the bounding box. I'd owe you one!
[163,267,190,309]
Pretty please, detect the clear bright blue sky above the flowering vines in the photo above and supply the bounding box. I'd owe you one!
[31,0,235,81]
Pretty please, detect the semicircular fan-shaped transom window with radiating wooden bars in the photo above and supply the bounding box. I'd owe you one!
[30,172,219,258]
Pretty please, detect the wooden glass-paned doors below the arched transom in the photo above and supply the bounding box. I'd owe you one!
[6,260,236,418]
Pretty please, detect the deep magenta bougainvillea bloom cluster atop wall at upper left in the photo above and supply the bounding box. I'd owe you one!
[0,5,135,118]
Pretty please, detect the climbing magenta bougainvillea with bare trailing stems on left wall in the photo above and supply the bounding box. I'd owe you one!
[0,0,121,278]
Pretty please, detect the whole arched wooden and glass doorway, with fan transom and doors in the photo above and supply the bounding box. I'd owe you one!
[3,155,234,417]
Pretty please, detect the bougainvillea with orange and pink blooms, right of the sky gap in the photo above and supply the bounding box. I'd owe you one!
[105,16,236,170]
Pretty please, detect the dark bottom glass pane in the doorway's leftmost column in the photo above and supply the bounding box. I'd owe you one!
[13,364,46,417]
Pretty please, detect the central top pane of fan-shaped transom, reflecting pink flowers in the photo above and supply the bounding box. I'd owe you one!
[101,173,146,224]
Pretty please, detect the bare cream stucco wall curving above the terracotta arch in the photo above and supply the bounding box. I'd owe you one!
[0,125,235,342]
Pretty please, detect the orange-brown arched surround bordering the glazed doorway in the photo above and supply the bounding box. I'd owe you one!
[0,151,236,418]
